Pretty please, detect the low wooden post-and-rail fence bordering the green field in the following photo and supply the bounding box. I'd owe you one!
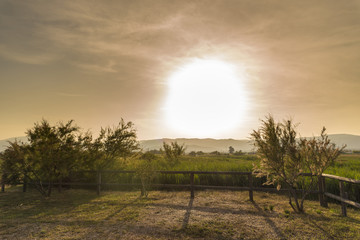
[1,170,360,216]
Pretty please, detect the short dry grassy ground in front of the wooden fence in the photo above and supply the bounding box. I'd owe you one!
[0,187,360,240]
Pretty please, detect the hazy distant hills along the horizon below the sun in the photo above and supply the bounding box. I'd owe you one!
[0,134,360,152]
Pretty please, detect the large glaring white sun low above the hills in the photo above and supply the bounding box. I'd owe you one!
[165,59,247,137]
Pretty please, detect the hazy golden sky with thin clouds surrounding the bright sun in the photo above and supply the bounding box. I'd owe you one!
[0,0,360,139]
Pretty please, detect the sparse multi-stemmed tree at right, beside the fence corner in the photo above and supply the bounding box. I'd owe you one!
[251,115,345,212]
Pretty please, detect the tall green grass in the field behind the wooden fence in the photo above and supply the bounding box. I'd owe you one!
[42,154,360,202]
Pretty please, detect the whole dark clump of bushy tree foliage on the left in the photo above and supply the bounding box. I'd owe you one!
[1,119,138,197]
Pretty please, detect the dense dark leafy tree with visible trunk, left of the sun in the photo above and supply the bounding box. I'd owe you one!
[25,120,81,197]
